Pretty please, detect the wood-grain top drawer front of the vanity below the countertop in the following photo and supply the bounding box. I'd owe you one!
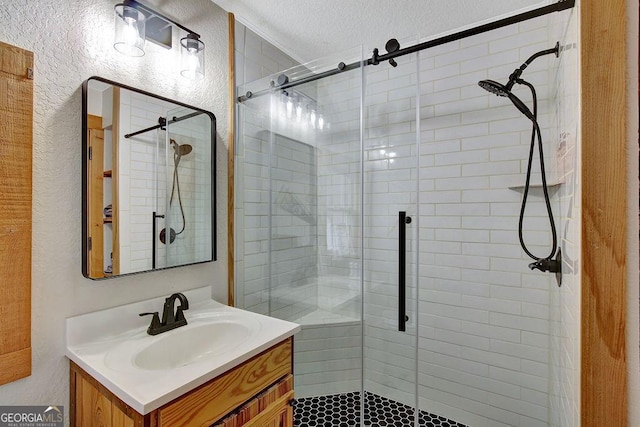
[158,338,292,427]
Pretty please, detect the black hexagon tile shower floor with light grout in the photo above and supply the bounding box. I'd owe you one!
[293,392,466,427]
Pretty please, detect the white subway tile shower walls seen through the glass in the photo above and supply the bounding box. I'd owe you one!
[236,7,580,427]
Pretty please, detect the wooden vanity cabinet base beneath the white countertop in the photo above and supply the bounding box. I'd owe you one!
[70,338,293,427]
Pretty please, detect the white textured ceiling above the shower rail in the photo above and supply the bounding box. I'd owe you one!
[213,0,554,63]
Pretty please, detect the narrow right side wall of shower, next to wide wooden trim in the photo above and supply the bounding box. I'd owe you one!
[549,9,582,427]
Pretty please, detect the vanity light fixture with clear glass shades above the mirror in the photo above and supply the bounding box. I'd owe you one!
[113,0,204,80]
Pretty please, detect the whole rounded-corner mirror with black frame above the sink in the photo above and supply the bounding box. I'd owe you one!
[82,77,216,279]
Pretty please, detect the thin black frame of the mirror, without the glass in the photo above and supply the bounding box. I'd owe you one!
[82,76,218,280]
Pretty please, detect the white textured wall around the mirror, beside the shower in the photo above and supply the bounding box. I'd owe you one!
[0,0,228,408]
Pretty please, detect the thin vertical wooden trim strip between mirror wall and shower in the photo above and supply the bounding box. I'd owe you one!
[227,13,236,307]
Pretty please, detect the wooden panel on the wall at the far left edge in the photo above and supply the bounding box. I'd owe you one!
[0,42,33,385]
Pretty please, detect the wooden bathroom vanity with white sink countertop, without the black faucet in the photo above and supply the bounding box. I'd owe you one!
[67,288,300,427]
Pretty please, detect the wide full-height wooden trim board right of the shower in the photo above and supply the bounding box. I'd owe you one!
[579,0,635,427]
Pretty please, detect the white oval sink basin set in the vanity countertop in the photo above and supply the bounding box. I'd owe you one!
[133,319,251,370]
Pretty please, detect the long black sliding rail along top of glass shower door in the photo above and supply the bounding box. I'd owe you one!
[238,0,576,102]
